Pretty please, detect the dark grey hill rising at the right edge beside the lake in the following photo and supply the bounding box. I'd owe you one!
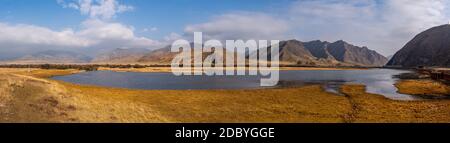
[387,24,450,67]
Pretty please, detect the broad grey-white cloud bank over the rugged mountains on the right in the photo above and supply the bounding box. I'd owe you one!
[185,0,450,55]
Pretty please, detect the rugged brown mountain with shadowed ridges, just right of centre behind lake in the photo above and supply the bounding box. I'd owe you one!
[258,40,387,66]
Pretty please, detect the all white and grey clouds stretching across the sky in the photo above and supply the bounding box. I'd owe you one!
[0,0,450,58]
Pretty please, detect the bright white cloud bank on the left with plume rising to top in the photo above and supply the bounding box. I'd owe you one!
[0,0,173,59]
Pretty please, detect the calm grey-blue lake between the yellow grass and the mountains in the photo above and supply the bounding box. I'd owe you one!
[53,69,418,100]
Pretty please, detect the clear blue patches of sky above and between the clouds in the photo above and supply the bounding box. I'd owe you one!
[0,0,292,39]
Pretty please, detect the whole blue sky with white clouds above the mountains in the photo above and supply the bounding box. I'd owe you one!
[0,0,450,59]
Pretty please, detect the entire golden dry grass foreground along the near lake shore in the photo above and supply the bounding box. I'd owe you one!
[0,69,450,123]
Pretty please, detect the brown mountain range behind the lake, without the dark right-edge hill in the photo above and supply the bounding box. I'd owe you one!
[3,40,388,67]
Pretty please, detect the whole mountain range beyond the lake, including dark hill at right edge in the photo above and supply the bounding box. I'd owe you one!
[6,24,450,67]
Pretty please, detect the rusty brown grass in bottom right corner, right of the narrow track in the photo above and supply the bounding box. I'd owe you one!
[342,85,450,123]
